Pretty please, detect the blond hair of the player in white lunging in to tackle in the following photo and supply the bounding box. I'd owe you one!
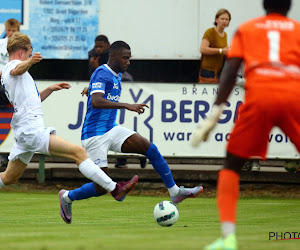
[7,32,32,55]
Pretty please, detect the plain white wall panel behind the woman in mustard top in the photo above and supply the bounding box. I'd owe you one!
[99,0,300,60]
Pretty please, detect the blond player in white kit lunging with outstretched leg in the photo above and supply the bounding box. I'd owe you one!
[0,32,137,223]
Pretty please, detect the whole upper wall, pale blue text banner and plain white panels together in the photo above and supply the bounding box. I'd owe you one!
[0,0,300,60]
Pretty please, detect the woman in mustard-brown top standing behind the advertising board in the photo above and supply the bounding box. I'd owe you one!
[198,9,231,83]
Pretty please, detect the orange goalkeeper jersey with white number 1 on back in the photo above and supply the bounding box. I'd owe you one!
[227,13,300,89]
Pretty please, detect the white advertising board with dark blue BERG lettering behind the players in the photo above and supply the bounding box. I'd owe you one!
[0,81,299,159]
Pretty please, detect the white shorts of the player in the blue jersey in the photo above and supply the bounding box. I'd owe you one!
[81,126,136,168]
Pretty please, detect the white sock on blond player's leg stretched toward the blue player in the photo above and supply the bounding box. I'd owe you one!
[79,159,117,192]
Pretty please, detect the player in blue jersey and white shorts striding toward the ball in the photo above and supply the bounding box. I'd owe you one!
[59,41,203,223]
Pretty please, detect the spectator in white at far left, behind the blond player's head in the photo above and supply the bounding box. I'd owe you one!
[0,18,21,76]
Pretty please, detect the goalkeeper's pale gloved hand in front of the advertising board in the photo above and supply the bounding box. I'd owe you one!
[192,105,224,147]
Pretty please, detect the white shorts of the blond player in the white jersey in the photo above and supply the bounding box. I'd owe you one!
[8,127,56,164]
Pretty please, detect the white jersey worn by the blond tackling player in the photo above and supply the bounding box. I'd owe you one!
[1,60,44,130]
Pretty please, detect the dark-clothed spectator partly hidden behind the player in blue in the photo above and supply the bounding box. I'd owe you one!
[88,35,144,168]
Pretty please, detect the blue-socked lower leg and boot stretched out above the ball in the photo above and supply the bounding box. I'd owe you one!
[145,143,203,204]
